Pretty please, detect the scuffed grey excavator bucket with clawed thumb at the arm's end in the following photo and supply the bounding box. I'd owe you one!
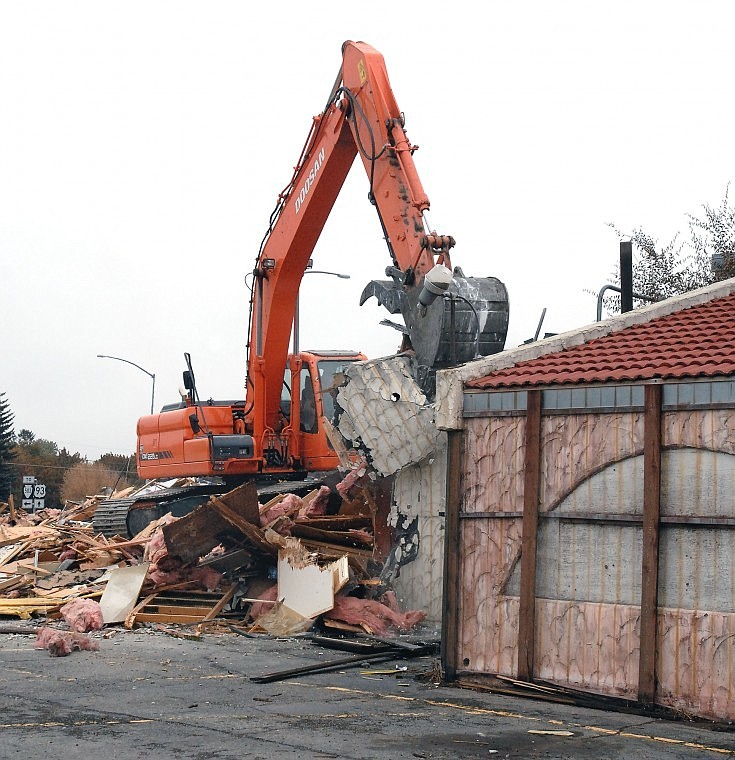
[360,267,509,369]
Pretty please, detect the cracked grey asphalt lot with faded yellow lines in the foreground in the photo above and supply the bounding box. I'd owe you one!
[0,628,735,760]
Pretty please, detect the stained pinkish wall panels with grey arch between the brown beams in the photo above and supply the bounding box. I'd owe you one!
[456,409,735,720]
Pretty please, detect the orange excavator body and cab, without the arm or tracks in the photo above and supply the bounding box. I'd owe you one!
[137,351,367,481]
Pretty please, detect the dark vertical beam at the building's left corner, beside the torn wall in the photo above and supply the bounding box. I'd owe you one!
[441,430,464,681]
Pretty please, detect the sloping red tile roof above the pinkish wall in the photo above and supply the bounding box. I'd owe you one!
[466,294,735,388]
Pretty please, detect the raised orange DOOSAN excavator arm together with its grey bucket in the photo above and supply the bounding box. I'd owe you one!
[246,41,508,434]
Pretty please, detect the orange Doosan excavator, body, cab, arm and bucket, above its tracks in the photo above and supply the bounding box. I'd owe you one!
[137,41,508,482]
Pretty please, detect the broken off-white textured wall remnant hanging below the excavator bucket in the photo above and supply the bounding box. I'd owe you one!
[337,356,447,628]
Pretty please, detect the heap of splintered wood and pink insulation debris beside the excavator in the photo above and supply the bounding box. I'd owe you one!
[0,470,425,655]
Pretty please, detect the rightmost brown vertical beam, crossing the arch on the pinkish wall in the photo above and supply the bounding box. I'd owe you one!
[638,385,662,704]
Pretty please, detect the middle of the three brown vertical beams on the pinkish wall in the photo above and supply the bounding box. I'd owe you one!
[518,390,541,681]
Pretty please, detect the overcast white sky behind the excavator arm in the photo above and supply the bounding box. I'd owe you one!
[0,0,735,459]
